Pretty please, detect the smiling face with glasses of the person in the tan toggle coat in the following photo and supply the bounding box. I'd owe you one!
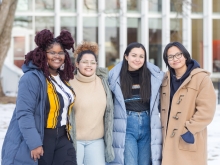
[167,46,187,71]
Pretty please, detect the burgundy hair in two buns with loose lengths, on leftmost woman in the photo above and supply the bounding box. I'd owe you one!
[24,29,74,81]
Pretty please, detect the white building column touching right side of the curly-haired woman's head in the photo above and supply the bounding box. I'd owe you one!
[98,0,106,67]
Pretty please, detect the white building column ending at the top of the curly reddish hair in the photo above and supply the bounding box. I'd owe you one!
[76,0,84,44]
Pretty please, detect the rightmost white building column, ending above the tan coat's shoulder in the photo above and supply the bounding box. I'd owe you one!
[203,0,213,73]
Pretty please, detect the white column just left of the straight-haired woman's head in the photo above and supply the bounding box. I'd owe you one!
[119,0,127,61]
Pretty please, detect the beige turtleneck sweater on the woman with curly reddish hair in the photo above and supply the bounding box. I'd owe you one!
[70,71,106,140]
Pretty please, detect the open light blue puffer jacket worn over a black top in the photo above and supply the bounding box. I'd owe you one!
[108,62,164,165]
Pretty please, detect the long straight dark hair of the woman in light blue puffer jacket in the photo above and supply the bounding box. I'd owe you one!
[120,42,151,102]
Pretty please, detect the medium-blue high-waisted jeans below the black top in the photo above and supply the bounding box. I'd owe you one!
[124,111,151,165]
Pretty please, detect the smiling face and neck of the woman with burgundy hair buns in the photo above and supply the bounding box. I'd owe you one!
[47,43,65,75]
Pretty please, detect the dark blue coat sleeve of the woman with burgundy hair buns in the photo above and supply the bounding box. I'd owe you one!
[16,73,42,150]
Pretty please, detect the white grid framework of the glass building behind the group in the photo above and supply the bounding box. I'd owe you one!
[0,0,220,96]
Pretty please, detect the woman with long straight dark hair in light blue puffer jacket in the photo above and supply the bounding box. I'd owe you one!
[109,43,164,165]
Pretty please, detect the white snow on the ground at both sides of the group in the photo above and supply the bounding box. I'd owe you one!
[0,104,220,165]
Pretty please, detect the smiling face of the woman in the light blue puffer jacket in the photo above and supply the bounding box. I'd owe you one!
[125,48,145,71]
